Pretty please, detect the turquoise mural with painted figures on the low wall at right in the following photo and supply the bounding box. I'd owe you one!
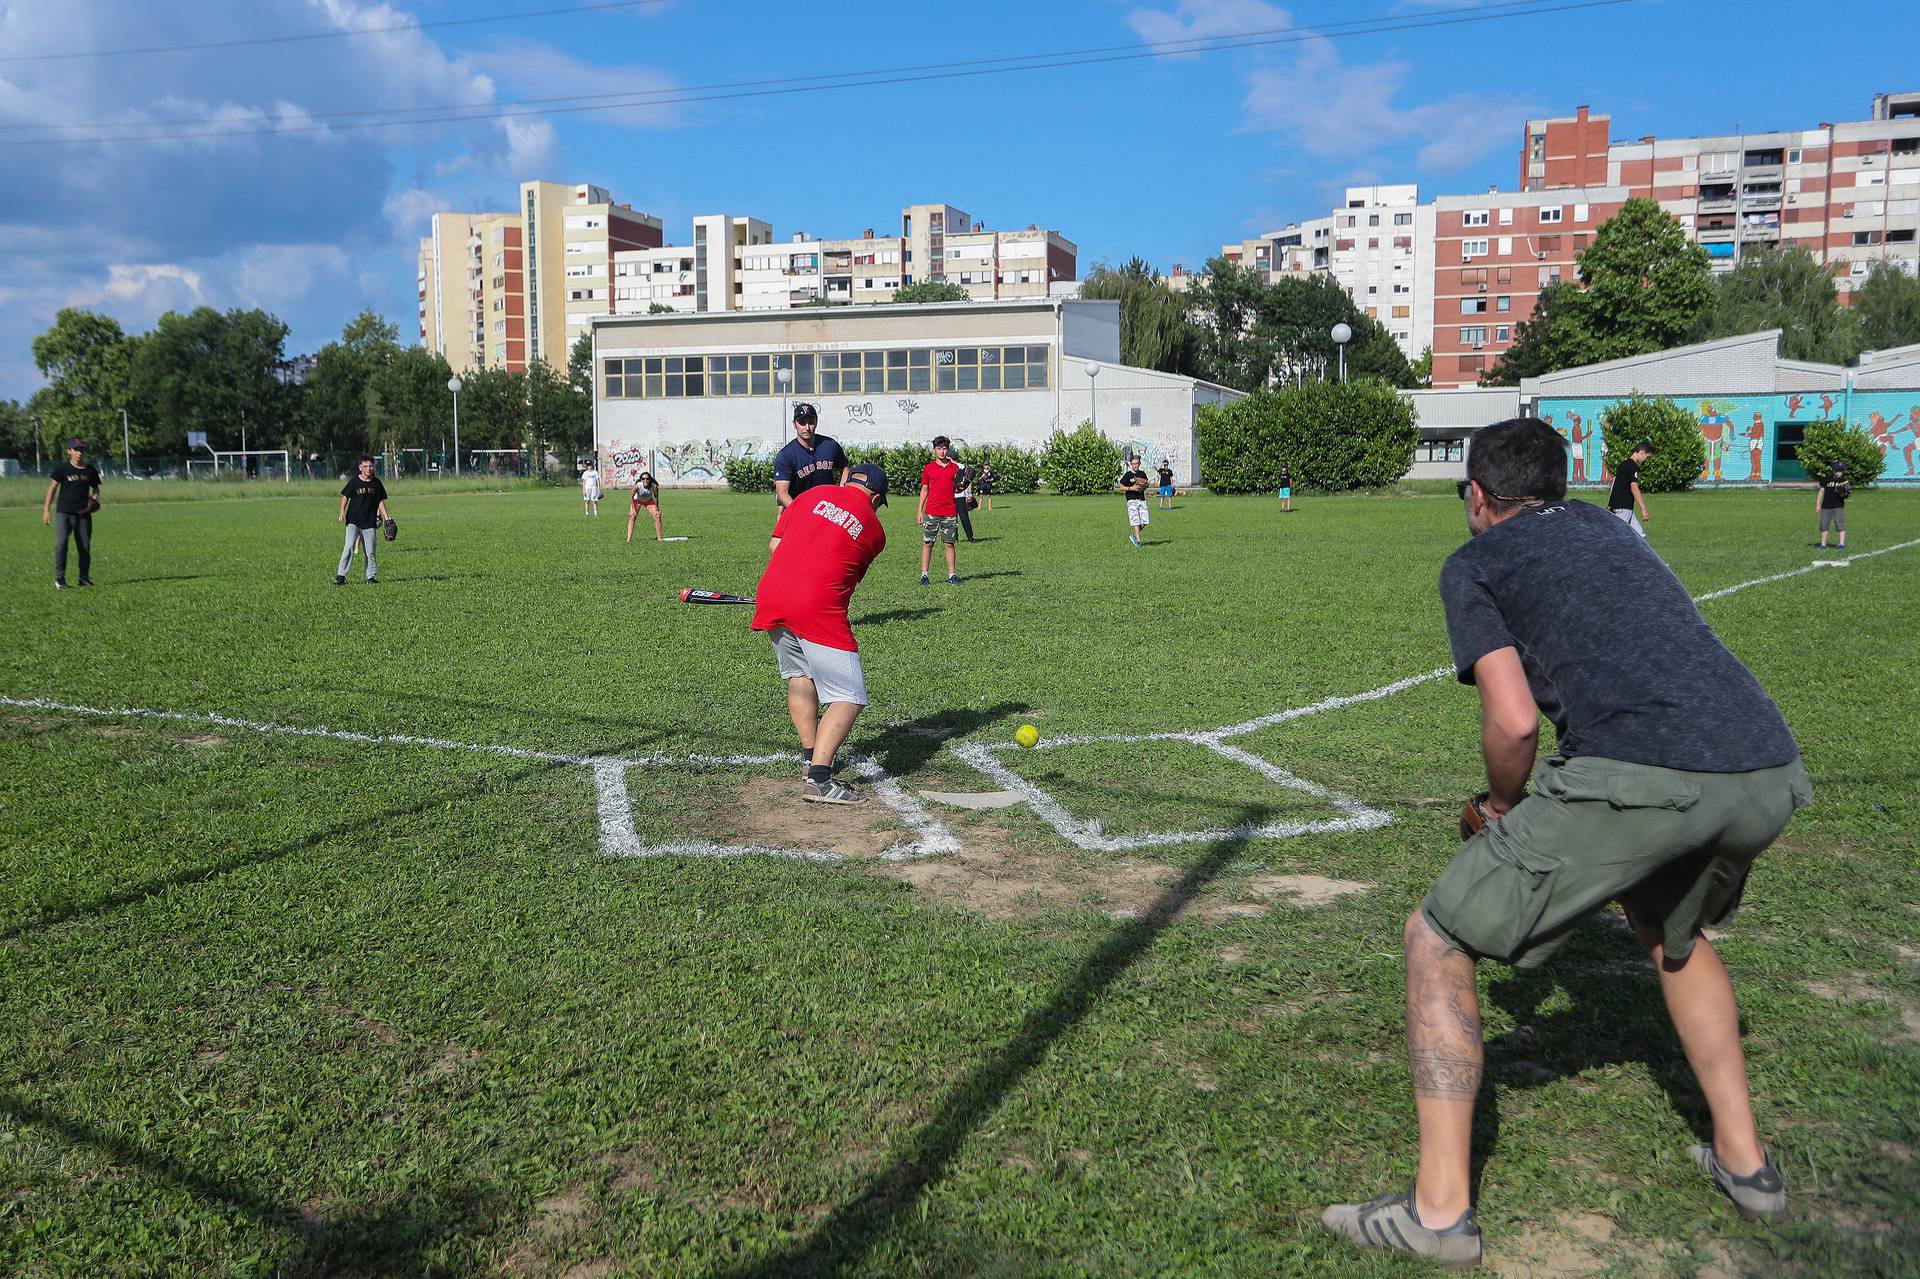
[1536,390,1920,486]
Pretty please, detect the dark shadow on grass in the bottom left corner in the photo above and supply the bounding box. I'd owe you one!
[0,1097,503,1275]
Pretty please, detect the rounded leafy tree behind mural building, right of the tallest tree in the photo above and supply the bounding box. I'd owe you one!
[1693,248,1860,365]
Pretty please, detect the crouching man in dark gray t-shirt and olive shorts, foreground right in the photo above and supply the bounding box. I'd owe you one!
[1323,419,1812,1264]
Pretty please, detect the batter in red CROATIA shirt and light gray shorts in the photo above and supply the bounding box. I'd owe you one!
[753,463,887,805]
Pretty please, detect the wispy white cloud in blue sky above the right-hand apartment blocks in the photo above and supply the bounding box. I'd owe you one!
[1242,38,1538,171]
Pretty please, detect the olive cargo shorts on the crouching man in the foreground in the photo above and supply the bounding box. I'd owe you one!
[1421,755,1812,968]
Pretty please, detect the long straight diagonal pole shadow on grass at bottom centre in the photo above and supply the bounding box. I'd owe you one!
[732,814,1254,1279]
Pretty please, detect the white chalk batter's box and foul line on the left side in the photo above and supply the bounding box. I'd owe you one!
[0,695,960,862]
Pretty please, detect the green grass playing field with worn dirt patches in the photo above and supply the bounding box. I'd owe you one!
[0,484,1920,1279]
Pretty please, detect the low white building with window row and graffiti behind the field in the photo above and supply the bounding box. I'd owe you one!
[593,298,1242,488]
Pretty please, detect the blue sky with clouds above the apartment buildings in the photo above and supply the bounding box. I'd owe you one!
[0,0,1920,398]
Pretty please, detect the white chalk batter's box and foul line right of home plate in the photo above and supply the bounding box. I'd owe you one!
[947,538,1920,853]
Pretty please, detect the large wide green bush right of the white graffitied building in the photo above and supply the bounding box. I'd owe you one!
[1194,378,1421,494]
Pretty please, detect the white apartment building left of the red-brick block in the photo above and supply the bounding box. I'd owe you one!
[1327,184,1434,359]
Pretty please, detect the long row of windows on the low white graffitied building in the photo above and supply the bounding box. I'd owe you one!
[601,346,1048,399]
